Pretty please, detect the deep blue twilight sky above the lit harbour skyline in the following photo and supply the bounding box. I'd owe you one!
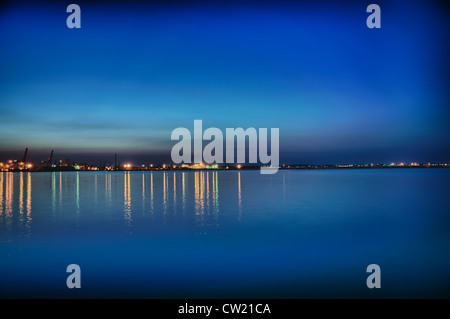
[0,1,450,164]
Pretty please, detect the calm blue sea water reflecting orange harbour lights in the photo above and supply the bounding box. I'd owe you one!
[0,168,450,298]
